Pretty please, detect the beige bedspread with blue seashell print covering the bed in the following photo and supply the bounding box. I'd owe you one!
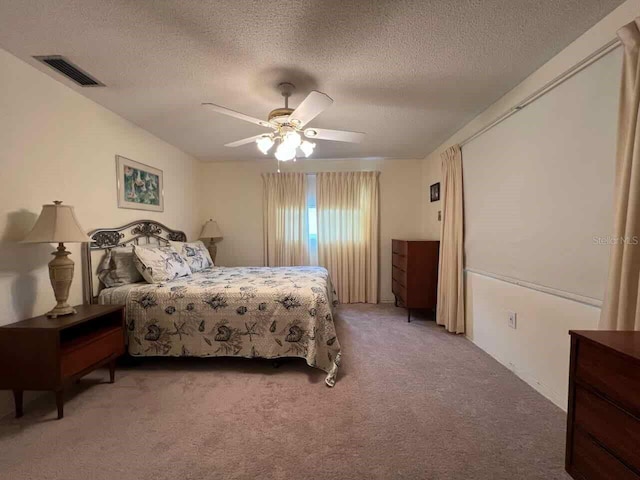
[100,267,341,387]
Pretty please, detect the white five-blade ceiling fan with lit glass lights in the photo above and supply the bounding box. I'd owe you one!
[202,82,365,166]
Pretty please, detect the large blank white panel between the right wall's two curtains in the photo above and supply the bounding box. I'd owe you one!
[462,51,621,300]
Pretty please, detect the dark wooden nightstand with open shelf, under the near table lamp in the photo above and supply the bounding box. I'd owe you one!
[0,305,125,418]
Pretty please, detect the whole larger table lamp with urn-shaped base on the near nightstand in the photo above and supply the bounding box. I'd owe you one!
[23,200,91,318]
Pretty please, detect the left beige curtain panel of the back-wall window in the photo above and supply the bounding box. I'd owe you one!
[262,173,309,267]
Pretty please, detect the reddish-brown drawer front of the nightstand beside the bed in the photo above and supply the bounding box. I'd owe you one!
[60,326,124,377]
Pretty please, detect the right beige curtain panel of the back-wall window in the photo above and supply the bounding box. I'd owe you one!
[316,172,380,303]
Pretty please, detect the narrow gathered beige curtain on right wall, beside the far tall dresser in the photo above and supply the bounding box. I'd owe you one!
[436,145,464,333]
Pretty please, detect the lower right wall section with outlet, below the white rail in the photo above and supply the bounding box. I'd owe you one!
[465,272,600,410]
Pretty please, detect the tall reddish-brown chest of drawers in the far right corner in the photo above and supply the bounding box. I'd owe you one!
[391,240,440,322]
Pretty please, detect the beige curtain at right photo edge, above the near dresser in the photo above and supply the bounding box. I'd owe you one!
[600,18,640,330]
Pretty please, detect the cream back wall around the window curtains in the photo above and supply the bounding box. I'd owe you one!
[199,160,427,302]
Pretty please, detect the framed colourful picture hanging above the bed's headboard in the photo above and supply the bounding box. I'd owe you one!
[116,155,164,212]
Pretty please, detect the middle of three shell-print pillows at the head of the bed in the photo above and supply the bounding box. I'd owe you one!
[133,245,191,283]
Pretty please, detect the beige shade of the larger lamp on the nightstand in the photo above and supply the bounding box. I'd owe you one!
[23,200,91,243]
